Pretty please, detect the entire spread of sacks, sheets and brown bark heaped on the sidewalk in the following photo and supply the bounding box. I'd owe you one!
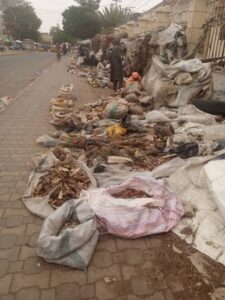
[23,52,225,269]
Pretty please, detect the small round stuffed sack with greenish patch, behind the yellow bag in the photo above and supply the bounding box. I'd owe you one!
[104,102,128,120]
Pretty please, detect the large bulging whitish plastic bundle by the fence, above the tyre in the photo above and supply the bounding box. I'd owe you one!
[143,56,213,108]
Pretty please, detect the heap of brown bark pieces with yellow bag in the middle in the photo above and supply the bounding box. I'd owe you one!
[37,92,175,170]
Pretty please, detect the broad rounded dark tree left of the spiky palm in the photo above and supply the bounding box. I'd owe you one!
[62,6,101,39]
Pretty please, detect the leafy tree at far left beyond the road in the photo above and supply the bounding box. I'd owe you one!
[3,3,41,41]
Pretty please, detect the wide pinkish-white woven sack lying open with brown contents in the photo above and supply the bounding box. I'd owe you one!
[81,175,183,238]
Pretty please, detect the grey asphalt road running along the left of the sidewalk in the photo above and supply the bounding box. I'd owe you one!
[0,52,56,97]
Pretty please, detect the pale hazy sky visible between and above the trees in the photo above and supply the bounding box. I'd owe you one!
[29,0,161,32]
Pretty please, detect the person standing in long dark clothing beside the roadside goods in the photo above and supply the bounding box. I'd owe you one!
[110,39,123,91]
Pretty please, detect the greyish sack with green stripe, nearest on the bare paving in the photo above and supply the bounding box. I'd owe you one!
[37,200,99,270]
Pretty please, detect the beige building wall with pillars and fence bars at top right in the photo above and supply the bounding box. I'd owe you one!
[116,0,225,58]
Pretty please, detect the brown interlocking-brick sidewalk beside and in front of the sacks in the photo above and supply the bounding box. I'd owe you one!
[0,62,224,300]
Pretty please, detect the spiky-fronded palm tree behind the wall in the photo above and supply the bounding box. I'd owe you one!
[98,5,130,29]
